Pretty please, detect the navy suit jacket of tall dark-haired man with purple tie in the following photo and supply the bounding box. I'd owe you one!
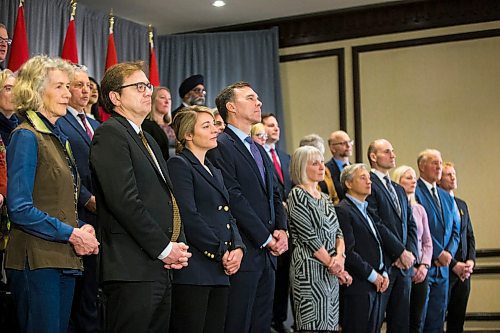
[207,127,286,271]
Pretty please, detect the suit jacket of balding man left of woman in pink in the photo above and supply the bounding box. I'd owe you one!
[366,172,418,264]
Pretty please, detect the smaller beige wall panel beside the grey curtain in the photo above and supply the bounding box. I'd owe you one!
[280,57,339,154]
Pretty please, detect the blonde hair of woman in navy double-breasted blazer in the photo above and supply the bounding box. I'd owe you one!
[171,105,214,154]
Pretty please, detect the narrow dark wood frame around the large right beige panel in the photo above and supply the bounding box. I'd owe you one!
[352,29,500,162]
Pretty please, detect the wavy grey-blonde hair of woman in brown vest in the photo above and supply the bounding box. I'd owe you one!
[14,55,74,116]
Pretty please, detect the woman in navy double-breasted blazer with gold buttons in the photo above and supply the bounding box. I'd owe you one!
[167,106,245,333]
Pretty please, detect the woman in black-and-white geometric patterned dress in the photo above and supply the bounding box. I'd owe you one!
[288,146,352,332]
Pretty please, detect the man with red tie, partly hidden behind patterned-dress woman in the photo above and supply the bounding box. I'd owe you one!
[262,113,292,333]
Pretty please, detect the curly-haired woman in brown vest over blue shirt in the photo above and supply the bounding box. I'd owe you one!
[5,56,99,333]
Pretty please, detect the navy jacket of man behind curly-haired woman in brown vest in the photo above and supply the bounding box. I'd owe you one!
[57,111,100,227]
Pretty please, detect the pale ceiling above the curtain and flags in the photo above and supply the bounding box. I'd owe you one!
[78,0,395,35]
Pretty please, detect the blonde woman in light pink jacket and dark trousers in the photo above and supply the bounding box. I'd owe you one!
[392,165,432,332]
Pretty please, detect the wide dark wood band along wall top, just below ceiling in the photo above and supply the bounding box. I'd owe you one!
[195,0,500,48]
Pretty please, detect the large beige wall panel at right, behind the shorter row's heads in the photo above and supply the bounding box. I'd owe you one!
[360,38,500,248]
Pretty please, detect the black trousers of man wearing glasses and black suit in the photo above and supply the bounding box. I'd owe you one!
[102,270,172,333]
